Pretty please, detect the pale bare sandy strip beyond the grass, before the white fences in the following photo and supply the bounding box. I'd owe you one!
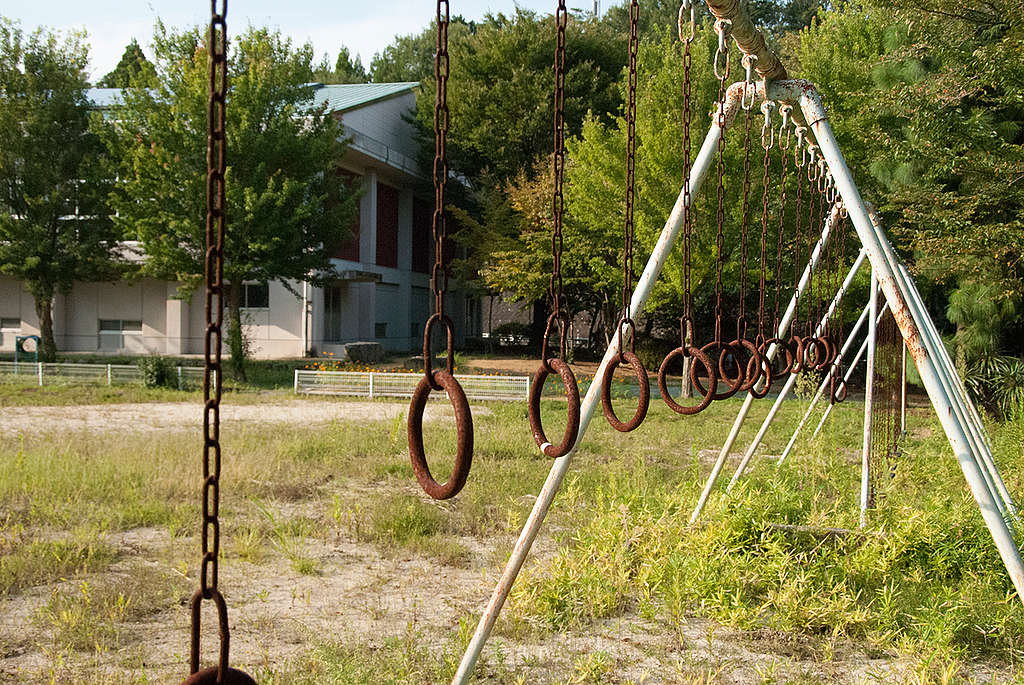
[0,399,489,433]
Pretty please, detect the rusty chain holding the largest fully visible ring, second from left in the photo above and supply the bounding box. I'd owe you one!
[424,0,449,368]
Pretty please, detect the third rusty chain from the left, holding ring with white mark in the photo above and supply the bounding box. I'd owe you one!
[541,0,569,362]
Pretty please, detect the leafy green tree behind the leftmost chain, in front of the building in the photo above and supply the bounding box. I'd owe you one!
[94,25,356,377]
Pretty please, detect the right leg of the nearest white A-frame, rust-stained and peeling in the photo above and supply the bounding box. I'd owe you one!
[800,88,1024,598]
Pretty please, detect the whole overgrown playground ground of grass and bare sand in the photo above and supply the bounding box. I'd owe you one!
[0,376,1024,684]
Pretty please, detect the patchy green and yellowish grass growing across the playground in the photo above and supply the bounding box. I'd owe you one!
[6,388,1024,684]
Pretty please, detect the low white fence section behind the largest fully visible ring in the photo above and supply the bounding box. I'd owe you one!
[295,370,529,400]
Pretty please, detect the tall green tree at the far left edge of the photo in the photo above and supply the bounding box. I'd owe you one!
[0,17,117,360]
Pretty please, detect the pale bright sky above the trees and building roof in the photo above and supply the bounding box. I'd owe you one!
[6,0,606,81]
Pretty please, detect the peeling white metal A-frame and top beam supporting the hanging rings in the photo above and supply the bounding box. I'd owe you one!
[452,0,1024,685]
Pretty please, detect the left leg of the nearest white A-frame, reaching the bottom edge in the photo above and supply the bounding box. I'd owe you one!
[452,106,724,685]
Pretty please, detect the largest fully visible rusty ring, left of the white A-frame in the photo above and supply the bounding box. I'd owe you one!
[408,369,473,500]
